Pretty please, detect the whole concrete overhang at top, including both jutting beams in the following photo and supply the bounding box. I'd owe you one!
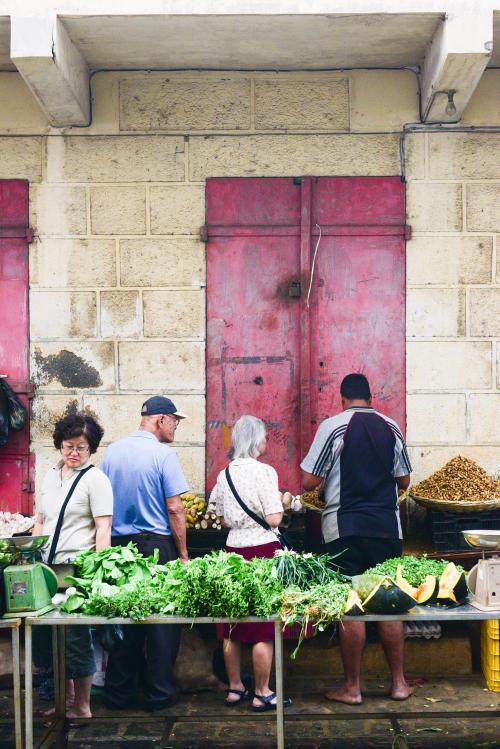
[0,5,500,126]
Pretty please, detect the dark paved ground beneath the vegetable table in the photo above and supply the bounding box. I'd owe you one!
[0,675,500,749]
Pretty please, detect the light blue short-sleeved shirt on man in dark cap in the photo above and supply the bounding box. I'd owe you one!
[100,430,189,536]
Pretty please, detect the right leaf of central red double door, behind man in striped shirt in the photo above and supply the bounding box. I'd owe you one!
[310,177,406,429]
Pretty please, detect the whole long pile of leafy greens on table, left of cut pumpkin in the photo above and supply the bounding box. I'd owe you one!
[61,544,349,628]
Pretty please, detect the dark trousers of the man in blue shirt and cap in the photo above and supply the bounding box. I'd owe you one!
[105,533,180,707]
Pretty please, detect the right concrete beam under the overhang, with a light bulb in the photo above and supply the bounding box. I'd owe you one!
[421,5,493,123]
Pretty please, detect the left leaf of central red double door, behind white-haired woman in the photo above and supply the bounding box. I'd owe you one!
[207,179,300,487]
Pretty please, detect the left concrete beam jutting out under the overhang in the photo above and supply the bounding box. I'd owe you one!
[11,14,90,127]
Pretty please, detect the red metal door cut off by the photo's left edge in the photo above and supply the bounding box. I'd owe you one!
[0,180,33,512]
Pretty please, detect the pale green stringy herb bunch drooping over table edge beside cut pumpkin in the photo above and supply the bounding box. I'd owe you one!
[280,580,350,658]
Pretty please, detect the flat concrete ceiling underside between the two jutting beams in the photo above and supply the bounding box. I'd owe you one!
[63,13,441,70]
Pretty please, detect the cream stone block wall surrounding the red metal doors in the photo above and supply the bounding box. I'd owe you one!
[0,71,500,491]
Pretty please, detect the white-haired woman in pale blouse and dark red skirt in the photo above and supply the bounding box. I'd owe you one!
[210,415,291,712]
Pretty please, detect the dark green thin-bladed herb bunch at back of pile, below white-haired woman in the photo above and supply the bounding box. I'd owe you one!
[273,551,345,590]
